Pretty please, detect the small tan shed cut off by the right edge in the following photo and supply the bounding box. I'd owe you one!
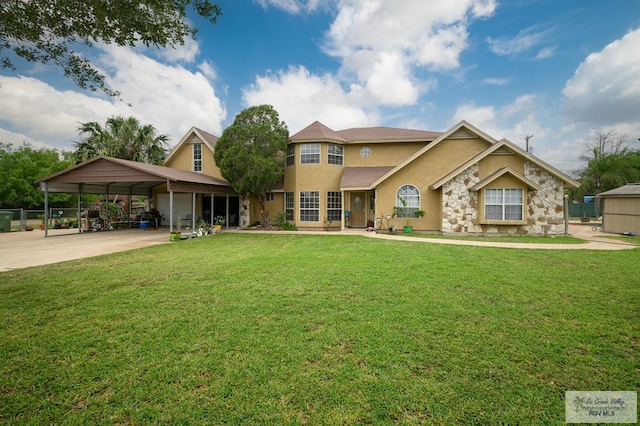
[597,183,640,235]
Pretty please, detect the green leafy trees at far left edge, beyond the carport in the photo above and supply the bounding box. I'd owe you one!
[0,142,76,209]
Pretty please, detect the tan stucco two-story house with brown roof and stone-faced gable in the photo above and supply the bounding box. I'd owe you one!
[165,121,579,234]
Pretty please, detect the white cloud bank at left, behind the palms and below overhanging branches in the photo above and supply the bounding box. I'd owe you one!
[0,46,226,149]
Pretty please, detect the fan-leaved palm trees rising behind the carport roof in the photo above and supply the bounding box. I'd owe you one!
[74,116,169,165]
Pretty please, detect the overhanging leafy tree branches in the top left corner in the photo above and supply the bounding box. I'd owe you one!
[0,0,222,96]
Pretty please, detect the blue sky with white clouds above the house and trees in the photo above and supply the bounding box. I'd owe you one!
[0,0,640,172]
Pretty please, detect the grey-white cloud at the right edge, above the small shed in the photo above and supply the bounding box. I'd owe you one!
[562,29,640,127]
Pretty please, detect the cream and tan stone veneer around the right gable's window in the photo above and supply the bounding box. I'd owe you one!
[442,162,564,235]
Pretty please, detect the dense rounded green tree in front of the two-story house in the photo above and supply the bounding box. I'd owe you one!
[214,105,289,227]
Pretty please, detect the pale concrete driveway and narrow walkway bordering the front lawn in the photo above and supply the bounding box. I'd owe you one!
[0,225,637,272]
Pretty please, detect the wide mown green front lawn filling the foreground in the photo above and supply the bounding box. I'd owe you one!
[0,233,640,424]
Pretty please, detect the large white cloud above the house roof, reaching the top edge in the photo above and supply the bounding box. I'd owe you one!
[243,0,497,128]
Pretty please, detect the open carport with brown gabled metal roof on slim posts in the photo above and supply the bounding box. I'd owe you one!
[38,157,234,237]
